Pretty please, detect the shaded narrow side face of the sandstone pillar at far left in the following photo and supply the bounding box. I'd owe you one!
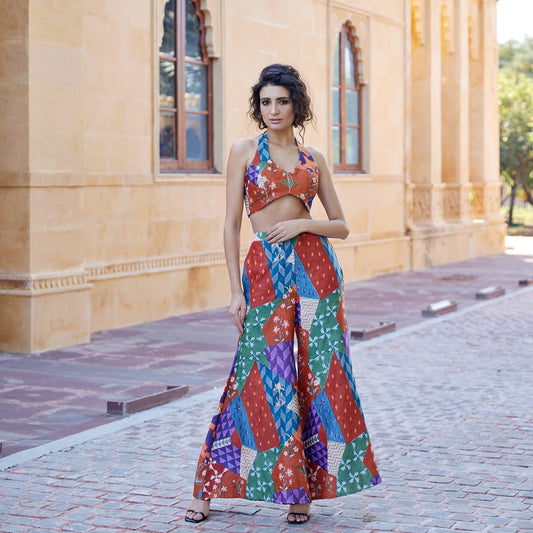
[0,0,31,350]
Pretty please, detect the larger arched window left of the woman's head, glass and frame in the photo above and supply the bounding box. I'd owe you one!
[159,0,213,171]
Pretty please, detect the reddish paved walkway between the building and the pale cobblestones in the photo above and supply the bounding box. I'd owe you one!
[0,237,533,456]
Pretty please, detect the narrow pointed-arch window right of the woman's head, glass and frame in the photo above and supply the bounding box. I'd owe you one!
[333,24,362,172]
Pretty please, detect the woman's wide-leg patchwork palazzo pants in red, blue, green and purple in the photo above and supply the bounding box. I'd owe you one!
[194,233,381,503]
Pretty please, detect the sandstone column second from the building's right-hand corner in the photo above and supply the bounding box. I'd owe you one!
[441,0,470,222]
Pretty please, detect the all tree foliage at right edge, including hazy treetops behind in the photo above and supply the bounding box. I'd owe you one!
[499,37,533,225]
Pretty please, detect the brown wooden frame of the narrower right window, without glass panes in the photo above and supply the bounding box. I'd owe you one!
[331,22,363,172]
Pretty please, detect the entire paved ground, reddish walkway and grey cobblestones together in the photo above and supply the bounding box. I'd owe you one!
[0,239,533,533]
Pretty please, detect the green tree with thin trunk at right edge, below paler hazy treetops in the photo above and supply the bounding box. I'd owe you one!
[499,72,533,226]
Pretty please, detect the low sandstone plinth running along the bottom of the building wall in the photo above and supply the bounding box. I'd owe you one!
[0,220,505,353]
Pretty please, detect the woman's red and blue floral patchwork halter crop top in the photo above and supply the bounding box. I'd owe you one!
[244,131,318,216]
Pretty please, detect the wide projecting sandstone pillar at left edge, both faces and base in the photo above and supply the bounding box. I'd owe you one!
[0,0,90,352]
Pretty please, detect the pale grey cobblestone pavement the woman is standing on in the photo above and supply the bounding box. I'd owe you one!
[0,288,533,533]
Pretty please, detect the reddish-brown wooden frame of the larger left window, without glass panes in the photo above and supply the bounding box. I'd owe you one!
[158,0,213,173]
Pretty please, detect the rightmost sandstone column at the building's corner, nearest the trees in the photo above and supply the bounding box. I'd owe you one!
[469,0,501,222]
